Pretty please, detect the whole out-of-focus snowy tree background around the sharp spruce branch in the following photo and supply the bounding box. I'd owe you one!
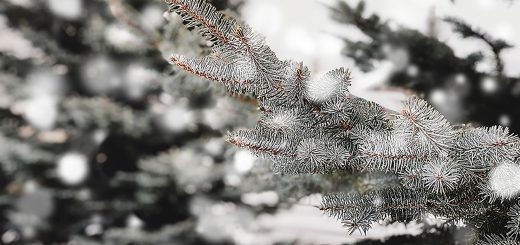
[0,0,520,244]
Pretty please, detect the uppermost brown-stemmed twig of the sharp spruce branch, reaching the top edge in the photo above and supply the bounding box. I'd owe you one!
[166,0,287,92]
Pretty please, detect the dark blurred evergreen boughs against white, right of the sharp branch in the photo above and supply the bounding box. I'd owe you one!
[331,1,520,133]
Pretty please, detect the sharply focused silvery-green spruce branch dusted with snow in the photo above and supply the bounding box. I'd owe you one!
[166,0,520,240]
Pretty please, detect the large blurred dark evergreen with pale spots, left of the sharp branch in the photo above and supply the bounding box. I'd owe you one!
[0,0,292,244]
